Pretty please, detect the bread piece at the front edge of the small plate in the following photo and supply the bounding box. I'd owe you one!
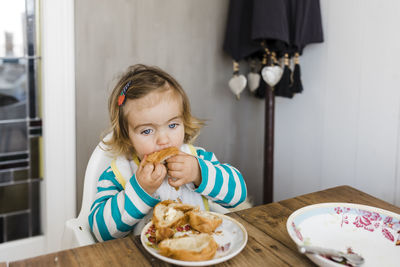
[158,233,218,261]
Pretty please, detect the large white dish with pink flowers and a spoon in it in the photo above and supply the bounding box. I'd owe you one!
[286,203,400,267]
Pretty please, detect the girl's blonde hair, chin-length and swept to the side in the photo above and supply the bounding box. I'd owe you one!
[104,64,204,157]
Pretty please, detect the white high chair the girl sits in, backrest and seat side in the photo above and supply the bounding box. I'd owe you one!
[61,134,112,249]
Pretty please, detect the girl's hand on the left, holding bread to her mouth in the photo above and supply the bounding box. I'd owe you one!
[136,158,167,195]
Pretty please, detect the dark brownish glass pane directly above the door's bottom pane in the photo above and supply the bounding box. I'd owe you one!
[0,183,29,214]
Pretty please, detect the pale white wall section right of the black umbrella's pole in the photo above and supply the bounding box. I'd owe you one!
[274,0,400,205]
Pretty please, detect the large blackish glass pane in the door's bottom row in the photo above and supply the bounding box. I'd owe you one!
[5,213,29,241]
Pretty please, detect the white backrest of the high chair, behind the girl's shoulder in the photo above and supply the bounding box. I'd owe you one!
[78,133,113,221]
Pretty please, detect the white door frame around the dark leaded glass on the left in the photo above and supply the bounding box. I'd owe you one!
[0,0,76,261]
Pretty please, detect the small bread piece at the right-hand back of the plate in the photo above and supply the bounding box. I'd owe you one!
[187,210,222,234]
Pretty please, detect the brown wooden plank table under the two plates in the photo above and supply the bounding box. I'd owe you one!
[9,186,400,267]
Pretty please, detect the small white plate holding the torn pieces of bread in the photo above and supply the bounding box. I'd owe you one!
[140,212,247,266]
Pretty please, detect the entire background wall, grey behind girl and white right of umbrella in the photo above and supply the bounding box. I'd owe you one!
[75,0,400,211]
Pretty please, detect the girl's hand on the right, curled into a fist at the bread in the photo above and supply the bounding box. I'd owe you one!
[167,152,201,187]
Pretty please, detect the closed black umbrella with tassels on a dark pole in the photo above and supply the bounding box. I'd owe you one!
[223,0,323,203]
